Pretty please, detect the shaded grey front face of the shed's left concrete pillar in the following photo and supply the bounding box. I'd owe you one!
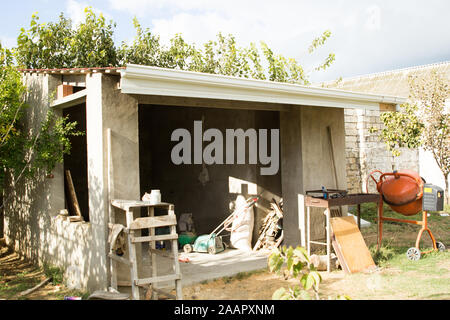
[97,74,141,282]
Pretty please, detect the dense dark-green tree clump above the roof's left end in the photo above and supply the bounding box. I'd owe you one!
[15,8,119,69]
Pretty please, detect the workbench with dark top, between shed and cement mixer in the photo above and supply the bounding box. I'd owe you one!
[305,193,380,272]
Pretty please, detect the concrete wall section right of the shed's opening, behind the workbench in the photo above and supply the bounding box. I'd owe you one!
[280,107,347,246]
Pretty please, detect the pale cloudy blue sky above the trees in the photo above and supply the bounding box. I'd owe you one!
[0,0,450,81]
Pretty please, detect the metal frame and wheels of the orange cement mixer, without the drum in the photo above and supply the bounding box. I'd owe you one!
[366,170,443,260]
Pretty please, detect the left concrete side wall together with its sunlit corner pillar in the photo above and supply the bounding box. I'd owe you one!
[5,73,140,291]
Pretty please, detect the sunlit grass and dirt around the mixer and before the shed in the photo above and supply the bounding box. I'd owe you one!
[183,204,450,300]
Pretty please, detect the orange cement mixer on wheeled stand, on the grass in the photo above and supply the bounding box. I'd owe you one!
[366,170,445,260]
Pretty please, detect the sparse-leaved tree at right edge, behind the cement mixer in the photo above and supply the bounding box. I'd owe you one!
[380,70,450,204]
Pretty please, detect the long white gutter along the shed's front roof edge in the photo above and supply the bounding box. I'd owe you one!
[120,65,406,110]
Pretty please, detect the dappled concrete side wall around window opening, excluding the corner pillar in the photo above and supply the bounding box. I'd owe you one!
[5,74,98,287]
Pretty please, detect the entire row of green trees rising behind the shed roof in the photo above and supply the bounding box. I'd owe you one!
[15,7,335,84]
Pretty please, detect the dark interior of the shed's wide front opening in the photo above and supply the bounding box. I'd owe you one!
[139,105,281,240]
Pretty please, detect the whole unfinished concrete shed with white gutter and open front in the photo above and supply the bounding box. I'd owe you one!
[4,65,404,291]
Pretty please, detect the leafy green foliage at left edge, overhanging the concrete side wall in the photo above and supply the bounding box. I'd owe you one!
[0,43,82,208]
